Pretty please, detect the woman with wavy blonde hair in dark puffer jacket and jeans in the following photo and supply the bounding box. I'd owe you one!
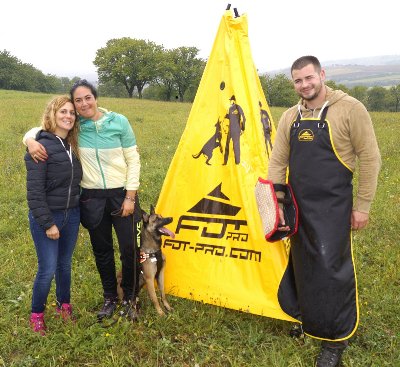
[25,96,82,335]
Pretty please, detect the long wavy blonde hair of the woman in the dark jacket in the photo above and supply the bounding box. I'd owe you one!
[41,96,79,159]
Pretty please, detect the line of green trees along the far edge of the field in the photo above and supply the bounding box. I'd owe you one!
[0,44,400,112]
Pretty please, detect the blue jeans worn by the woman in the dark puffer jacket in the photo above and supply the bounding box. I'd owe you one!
[28,207,80,313]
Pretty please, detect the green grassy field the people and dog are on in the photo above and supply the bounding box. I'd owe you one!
[0,91,400,367]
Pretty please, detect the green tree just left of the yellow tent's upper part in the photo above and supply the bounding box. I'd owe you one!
[169,47,205,102]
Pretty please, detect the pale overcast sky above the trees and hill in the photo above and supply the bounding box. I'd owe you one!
[0,0,400,77]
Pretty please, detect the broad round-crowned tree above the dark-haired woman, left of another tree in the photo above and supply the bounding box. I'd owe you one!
[93,37,163,98]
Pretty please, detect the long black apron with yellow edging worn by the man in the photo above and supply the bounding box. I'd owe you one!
[278,108,358,341]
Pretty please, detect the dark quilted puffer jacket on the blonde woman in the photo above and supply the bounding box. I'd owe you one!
[25,131,82,230]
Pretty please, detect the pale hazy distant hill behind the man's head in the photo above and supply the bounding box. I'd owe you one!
[267,55,400,87]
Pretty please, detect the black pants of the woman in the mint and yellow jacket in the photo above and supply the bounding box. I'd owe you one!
[81,190,140,299]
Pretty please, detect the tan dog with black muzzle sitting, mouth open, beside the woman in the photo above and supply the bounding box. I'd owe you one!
[117,205,175,316]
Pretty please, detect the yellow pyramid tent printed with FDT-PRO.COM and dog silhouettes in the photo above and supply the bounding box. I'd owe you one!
[156,5,294,321]
